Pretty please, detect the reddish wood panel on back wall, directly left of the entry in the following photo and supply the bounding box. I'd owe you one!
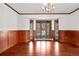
[17,30,30,42]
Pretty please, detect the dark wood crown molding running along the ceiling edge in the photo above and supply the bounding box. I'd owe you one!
[4,3,79,15]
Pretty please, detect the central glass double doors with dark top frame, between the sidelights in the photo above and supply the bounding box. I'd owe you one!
[36,21,51,40]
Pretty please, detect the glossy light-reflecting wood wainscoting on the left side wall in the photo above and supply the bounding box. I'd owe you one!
[0,30,18,53]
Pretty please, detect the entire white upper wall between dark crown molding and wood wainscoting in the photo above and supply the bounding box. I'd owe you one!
[0,4,79,30]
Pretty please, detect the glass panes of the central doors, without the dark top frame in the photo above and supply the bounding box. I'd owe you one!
[36,22,50,39]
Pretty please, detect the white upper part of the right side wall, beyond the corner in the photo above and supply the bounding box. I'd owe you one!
[70,10,79,30]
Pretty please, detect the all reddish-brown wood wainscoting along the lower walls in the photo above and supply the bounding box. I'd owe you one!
[0,30,79,53]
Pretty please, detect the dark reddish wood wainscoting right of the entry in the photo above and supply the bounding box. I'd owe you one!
[59,30,79,47]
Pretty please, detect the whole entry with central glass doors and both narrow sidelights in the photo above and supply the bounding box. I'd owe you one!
[30,19,59,41]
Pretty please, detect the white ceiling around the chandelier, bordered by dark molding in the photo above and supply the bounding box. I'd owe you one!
[8,3,79,13]
